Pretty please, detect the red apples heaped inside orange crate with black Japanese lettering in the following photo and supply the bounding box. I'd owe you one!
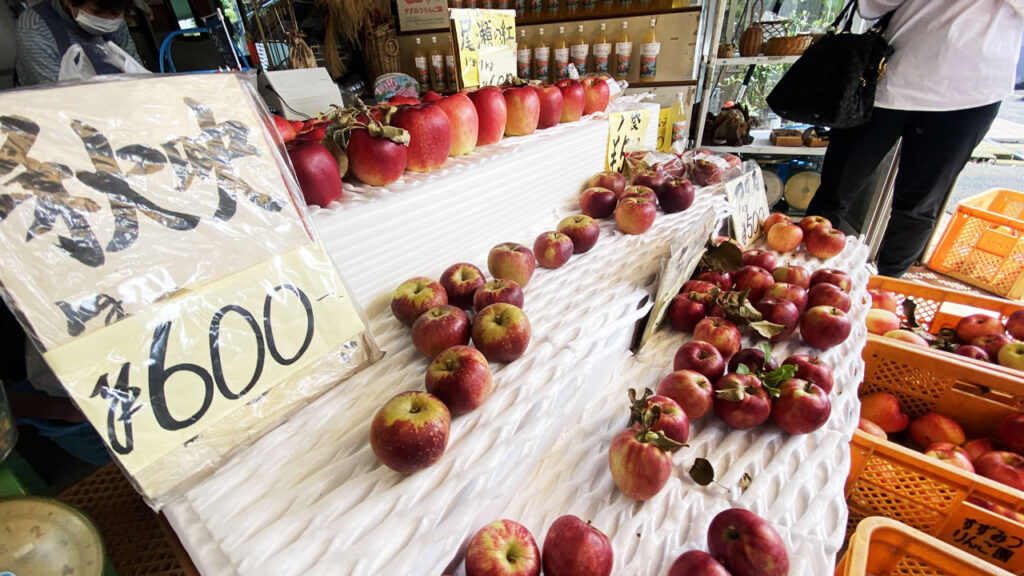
[858,392,1024,490]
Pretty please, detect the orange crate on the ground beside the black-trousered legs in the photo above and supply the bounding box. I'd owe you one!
[928,189,1024,300]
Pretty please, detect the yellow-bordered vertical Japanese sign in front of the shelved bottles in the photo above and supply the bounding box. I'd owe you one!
[451,8,516,87]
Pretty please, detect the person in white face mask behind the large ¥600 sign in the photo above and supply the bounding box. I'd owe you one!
[15,0,139,86]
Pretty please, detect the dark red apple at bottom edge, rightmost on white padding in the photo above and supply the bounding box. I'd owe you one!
[708,508,790,576]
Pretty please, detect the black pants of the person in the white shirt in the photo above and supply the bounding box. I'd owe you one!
[807,102,999,278]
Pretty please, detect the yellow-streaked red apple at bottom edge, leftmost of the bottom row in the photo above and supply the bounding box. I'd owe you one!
[466,520,541,576]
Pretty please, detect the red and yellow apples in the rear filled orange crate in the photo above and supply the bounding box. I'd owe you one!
[865,288,1024,370]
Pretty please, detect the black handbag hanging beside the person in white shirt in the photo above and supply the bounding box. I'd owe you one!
[767,0,893,128]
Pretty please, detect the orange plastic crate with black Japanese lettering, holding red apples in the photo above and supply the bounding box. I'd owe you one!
[846,335,1024,575]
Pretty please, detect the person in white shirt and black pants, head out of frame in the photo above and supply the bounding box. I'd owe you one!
[807,0,1024,278]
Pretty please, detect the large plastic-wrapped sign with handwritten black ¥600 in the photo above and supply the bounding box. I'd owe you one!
[0,74,380,507]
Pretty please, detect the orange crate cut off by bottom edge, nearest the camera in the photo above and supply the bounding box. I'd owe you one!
[836,517,1010,576]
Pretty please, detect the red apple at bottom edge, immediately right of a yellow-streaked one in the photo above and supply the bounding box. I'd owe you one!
[542,515,614,576]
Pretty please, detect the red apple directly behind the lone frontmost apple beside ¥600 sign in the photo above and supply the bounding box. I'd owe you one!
[425,345,490,415]
